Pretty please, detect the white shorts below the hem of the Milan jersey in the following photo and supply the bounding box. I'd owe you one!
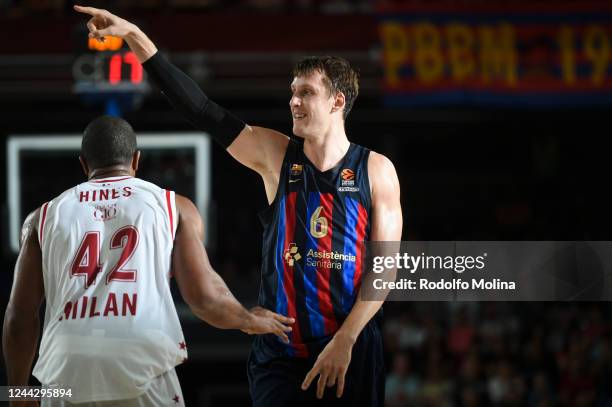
[40,369,185,407]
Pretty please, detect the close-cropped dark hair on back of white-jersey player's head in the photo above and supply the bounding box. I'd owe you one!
[81,116,137,169]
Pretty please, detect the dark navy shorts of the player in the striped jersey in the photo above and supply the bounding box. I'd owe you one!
[247,320,385,407]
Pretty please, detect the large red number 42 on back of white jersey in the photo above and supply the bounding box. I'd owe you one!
[70,226,139,288]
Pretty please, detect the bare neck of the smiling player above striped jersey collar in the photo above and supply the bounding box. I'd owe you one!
[304,127,351,172]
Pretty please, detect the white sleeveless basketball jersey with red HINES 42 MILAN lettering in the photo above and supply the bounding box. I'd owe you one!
[33,177,187,402]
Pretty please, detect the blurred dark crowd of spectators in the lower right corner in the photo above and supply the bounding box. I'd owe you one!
[385,302,612,407]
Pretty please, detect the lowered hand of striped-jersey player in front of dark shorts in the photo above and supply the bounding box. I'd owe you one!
[302,334,353,399]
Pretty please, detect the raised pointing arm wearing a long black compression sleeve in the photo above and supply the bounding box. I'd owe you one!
[74,6,289,197]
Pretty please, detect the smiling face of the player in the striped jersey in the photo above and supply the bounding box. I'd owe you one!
[289,71,344,139]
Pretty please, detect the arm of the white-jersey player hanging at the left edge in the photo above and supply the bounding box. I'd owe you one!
[2,210,45,386]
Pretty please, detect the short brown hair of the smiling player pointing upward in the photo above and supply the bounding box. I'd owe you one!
[293,55,359,120]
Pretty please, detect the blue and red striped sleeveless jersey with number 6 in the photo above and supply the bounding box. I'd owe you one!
[254,140,372,359]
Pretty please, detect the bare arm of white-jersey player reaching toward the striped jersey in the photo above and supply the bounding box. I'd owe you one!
[172,195,294,341]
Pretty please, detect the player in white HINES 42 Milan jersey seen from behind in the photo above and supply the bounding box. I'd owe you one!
[3,116,293,406]
